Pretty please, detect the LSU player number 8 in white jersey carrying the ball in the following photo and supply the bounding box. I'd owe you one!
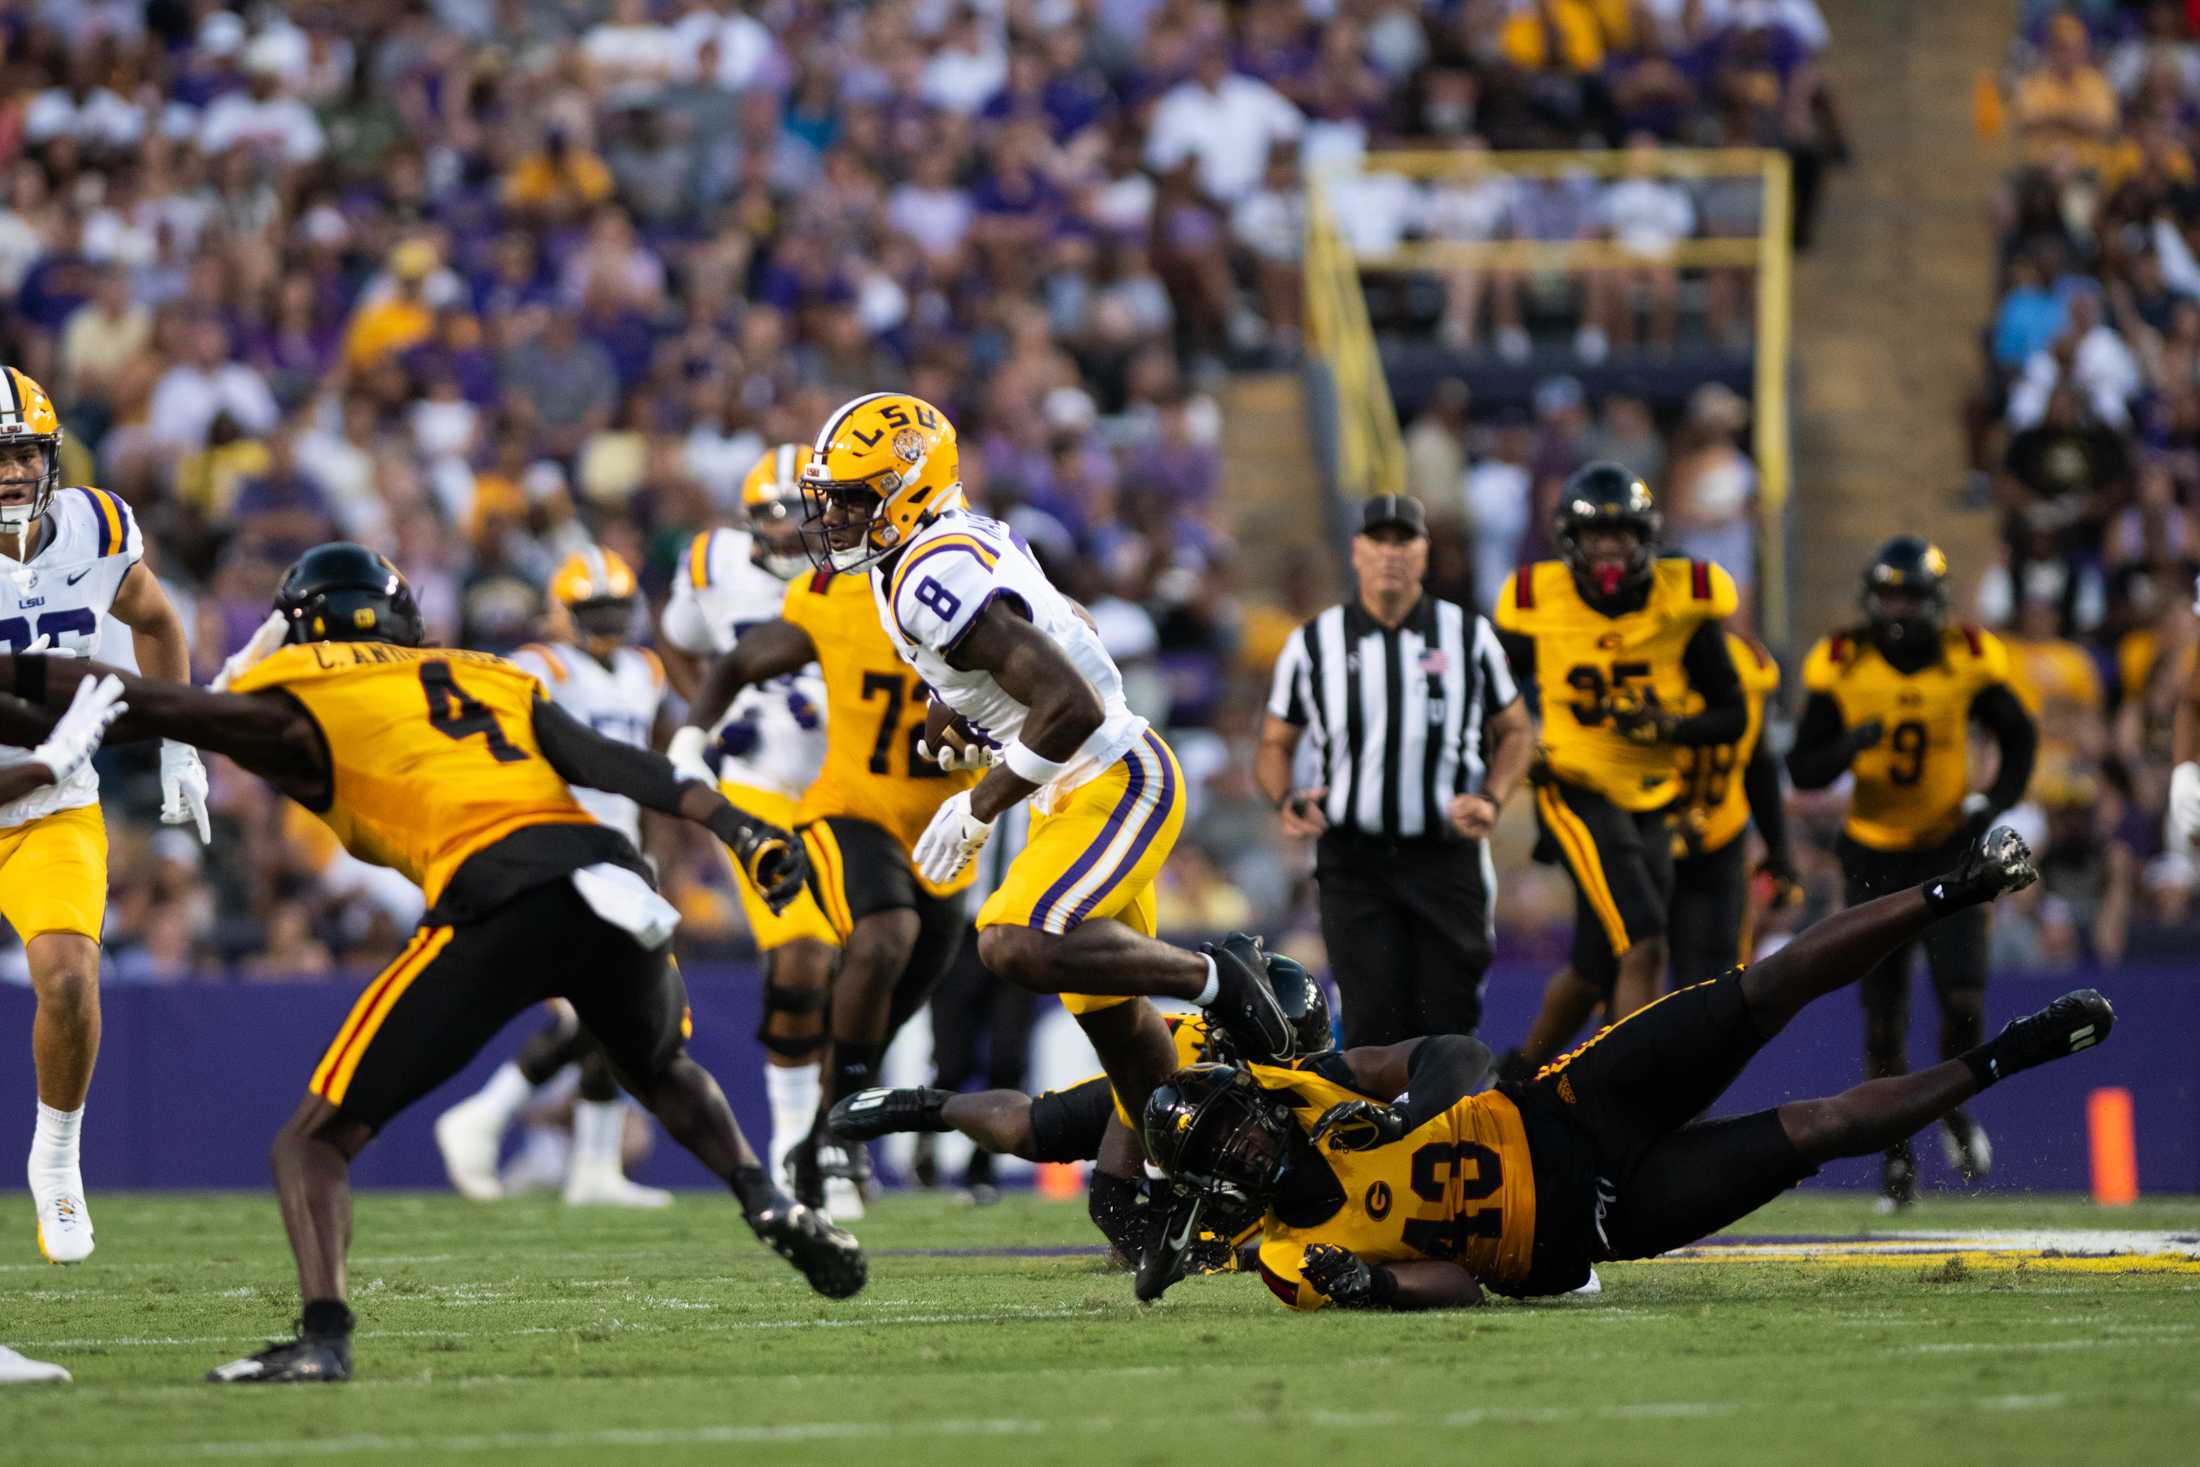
[803,391,1291,1247]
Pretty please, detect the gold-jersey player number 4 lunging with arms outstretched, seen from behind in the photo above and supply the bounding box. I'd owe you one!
[0,543,865,1381]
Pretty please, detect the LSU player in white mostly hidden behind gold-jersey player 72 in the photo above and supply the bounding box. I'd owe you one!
[658,444,840,1218]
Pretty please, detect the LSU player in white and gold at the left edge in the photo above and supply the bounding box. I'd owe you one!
[0,367,209,1262]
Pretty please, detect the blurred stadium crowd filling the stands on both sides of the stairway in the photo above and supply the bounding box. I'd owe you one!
[21,0,2200,983]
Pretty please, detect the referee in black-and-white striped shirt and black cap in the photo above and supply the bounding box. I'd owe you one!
[1254,495,1533,1047]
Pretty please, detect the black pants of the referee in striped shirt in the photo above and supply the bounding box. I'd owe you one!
[1313,831,1489,1049]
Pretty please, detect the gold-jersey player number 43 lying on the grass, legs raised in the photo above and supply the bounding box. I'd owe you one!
[1144,829,2114,1309]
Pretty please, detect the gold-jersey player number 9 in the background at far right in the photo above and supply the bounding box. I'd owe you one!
[1789,534,2039,1207]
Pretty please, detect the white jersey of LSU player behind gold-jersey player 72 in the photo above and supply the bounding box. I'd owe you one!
[664,530,825,798]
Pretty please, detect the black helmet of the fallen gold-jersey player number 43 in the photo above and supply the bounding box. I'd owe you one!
[1142,1065,1307,1207]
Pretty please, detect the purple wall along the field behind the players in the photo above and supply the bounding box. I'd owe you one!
[0,968,2200,1196]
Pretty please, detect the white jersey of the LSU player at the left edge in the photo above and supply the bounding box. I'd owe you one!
[0,488,145,829]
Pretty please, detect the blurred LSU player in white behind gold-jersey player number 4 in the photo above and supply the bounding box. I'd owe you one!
[436,548,673,1207]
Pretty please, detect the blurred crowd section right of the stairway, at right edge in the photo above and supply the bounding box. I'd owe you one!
[1967,0,2200,963]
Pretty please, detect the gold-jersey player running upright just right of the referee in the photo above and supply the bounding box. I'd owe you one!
[1492,464,1749,1065]
